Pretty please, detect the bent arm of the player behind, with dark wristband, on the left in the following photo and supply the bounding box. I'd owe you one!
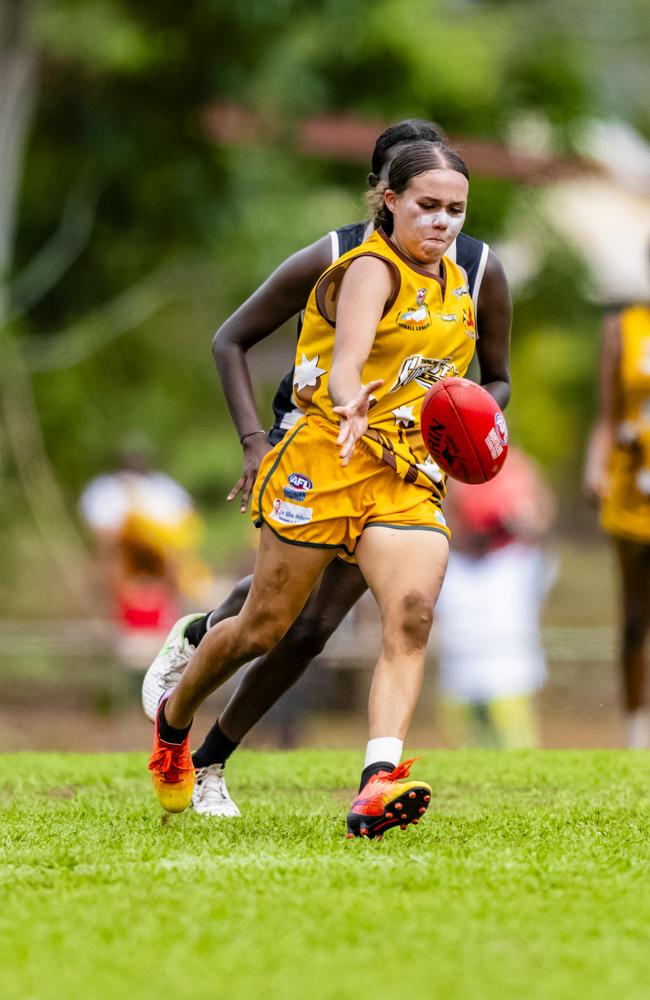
[212,236,332,512]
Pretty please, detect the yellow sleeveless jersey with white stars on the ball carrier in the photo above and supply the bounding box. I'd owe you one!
[293,229,477,493]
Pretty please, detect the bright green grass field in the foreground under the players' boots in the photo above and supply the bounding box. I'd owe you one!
[0,751,650,1000]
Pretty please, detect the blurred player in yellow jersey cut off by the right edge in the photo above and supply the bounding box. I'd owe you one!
[584,258,650,748]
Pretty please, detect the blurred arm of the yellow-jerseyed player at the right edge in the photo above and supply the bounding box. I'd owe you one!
[583,316,621,504]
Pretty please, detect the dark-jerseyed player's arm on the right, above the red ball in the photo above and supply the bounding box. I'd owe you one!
[476,250,512,409]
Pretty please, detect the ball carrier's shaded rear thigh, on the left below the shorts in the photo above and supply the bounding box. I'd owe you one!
[241,524,335,634]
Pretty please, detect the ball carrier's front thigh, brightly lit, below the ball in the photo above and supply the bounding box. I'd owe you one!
[355,525,449,625]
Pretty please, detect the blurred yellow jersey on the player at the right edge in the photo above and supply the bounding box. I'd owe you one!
[601,305,650,543]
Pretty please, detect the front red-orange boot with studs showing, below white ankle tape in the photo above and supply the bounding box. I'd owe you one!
[347,757,431,840]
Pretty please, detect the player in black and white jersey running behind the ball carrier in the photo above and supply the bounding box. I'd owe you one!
[143,120,511,816]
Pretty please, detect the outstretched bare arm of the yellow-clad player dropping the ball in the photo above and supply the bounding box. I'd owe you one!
[328,257,394,465]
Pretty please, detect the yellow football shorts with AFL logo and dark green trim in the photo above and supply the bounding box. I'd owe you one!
[251,414,450,555]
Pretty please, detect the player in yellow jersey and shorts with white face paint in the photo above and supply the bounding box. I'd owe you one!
[149,142,506,836]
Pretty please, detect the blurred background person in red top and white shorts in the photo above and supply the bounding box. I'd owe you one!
[436,448,555,749]
